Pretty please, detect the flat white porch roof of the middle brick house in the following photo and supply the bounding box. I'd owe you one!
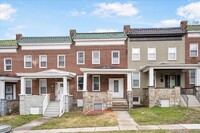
[80,68,135,74]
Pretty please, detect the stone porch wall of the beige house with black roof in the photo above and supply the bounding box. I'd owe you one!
[148,87,181,107]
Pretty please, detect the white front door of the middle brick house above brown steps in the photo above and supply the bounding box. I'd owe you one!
[109,78,124,98]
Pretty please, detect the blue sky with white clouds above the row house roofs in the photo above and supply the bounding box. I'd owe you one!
[0,0,200,40]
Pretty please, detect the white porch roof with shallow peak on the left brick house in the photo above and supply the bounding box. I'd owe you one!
[16,69,76,78]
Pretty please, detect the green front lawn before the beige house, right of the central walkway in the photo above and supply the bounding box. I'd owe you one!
[129,107,200,125]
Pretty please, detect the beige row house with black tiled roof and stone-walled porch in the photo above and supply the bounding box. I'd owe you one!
[127,23,200,107]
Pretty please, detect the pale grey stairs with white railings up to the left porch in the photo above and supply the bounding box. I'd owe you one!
[44,101,60,117]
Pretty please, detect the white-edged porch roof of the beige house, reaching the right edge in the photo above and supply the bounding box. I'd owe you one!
[140,63,200,72]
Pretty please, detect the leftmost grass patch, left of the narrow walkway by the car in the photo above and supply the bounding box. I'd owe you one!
[0,115,42,128]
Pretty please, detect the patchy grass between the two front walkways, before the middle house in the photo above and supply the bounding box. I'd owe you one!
[33,111,118,129]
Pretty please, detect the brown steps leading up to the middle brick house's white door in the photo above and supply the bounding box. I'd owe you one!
[112,98,128,111]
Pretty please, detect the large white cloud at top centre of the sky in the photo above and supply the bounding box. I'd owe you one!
[93,2,139,17]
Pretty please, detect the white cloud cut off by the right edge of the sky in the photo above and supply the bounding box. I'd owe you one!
[177,2,200,20]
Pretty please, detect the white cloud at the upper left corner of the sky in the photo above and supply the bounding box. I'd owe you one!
[0,3,17,20]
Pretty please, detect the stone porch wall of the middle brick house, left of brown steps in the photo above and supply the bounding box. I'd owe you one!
[83,90,112,110]
